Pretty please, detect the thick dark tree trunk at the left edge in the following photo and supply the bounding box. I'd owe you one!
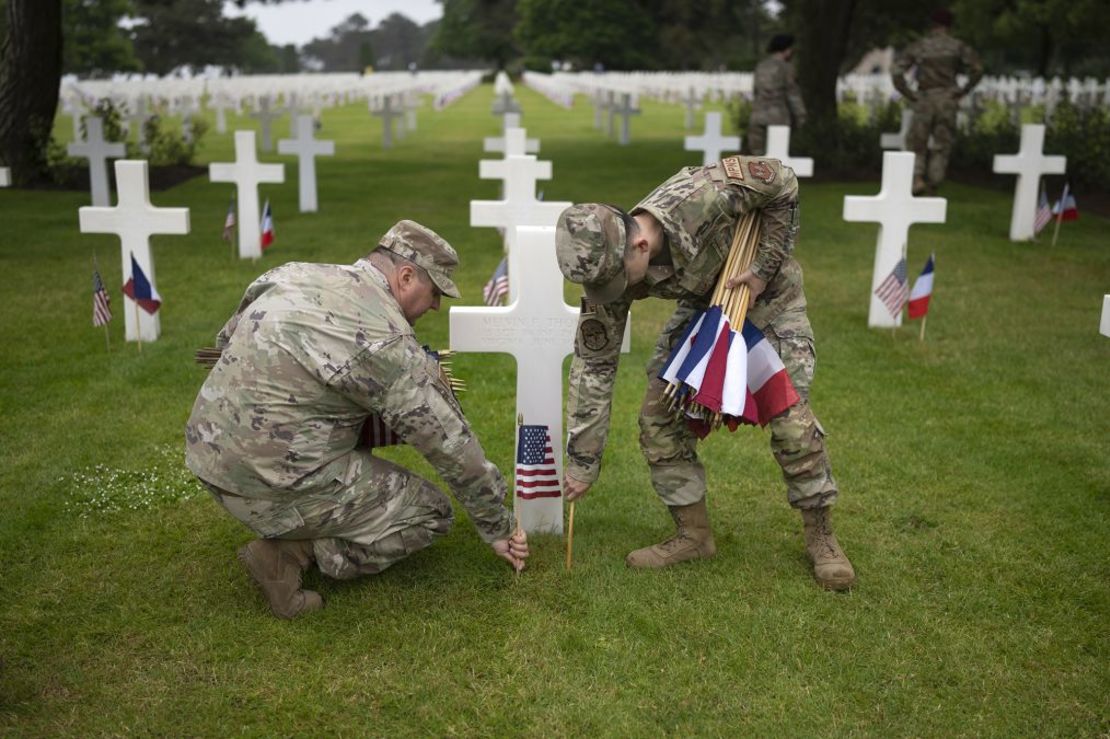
[0,0,62,183]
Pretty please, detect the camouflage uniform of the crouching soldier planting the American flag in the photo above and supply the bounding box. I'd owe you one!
[185,238,511,578]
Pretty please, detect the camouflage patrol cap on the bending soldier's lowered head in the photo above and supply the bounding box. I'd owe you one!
[555,203,628,304]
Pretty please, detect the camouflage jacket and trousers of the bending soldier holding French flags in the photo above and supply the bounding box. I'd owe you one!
[559,156,837,508]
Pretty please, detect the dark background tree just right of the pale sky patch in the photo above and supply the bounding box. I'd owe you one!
[432,0,519,69]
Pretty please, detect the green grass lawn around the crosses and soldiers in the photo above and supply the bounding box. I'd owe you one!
[0,85,1110,736]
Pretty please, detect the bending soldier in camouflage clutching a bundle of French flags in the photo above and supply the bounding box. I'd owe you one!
[556,156,855,589]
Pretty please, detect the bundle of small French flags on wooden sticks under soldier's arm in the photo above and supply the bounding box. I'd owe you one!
[659,212,798,437]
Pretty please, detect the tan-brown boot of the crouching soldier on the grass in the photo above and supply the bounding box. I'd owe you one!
[239,539,324,618]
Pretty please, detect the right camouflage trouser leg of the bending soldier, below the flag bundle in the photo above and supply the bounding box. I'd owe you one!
[764,312,837,508]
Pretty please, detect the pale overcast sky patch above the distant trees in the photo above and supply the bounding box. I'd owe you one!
[224,0,443,47]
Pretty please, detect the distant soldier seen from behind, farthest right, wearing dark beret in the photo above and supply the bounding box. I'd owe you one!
[890,9,982,195]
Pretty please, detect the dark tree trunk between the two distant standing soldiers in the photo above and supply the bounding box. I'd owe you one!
[793,0,856,130]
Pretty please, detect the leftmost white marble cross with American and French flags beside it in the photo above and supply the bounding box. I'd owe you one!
[78,160,189,342]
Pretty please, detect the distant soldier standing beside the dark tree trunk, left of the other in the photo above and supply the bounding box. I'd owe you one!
[748,33,806,156]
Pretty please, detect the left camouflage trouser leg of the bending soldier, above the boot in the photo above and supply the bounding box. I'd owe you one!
[639,377,706,506]
